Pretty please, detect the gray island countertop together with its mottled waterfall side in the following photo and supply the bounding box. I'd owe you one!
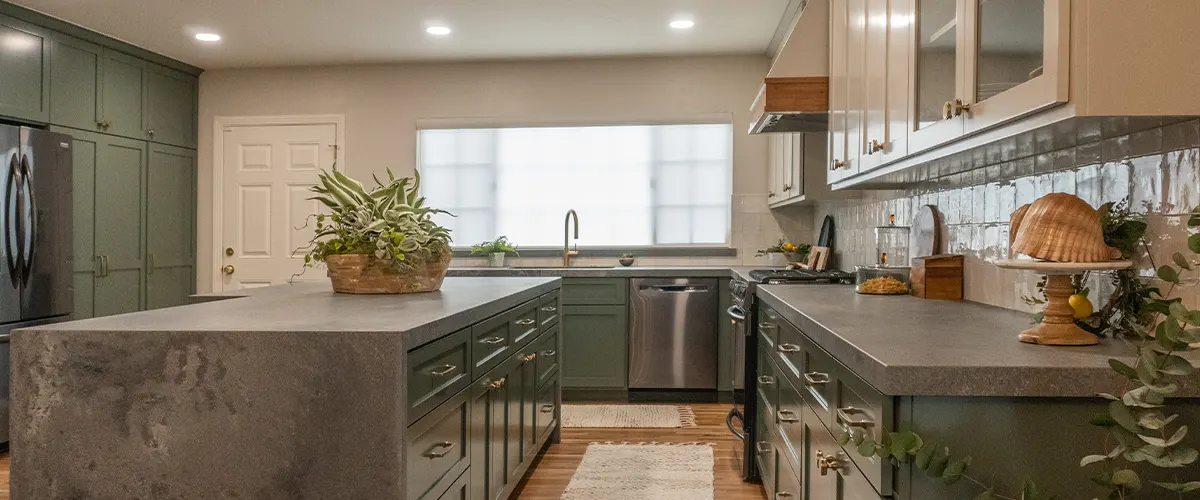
[11,278,560,500]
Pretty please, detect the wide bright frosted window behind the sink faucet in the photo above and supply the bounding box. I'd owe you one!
[418,124,733,248]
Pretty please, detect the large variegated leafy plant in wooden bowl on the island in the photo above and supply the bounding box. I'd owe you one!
[305,170,450,294]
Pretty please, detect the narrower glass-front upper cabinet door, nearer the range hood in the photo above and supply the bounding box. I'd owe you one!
[908,0,964,153]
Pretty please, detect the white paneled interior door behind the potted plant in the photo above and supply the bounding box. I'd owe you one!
[220,124,337,290]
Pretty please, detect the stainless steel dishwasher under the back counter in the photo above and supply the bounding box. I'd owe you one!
[629,278,718,390]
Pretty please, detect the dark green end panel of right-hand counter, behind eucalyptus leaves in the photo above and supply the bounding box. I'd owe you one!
[897,397,1200,500]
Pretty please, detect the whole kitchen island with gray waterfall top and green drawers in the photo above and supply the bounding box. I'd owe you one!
[11,277,560,500]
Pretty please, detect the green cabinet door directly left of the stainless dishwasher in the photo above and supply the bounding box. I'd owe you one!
[560,306,629,388]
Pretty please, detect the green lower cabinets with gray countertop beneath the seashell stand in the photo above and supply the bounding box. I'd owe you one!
[748,285,1200,500]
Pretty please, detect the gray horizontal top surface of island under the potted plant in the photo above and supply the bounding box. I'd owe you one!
[28,277,559,347]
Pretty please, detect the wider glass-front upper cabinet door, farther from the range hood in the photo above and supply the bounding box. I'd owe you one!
[955,0,1070,133]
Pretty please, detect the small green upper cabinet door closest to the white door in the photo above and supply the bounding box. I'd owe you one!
[145,65,197,147]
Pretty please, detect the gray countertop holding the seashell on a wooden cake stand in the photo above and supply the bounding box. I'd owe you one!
[757,285,1200,397]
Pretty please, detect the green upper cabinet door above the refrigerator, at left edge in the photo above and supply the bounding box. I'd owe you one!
[0,16,50,122]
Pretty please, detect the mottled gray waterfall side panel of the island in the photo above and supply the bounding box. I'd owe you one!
[11,331,406,500]
